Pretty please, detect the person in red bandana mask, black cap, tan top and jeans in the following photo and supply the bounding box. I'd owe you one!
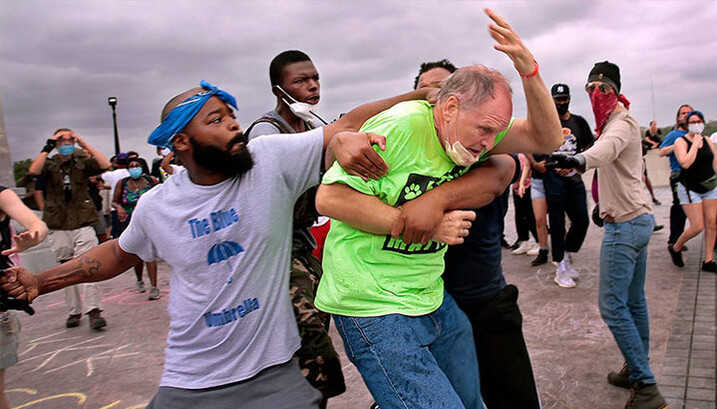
[548,61,667,409]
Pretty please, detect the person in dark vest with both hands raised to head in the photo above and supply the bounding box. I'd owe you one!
[27,128,110,330]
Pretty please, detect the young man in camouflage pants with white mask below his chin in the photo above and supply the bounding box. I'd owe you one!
[245,50,346,408]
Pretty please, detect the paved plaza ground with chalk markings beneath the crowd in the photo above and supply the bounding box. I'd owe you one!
[6,188,715,409]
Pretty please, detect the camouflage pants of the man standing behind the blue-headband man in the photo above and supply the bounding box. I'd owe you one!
[289,250,346,398]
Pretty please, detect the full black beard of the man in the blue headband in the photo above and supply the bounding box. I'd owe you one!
[189,132,254,177]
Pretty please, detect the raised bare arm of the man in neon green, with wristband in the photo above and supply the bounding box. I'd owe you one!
[485,9,562,153]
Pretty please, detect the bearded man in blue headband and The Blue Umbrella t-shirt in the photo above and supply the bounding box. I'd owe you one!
[0,81,440,409]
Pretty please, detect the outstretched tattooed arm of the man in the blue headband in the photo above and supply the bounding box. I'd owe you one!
[0,240,141,301]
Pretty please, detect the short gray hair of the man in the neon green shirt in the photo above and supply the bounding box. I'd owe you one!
[437,64,513,108]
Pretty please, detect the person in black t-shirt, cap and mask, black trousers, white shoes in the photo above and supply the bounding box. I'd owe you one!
[543,84,595,288]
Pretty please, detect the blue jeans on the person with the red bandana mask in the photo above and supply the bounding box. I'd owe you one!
[599,214,656,383]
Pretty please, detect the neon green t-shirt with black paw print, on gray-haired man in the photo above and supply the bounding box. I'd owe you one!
[315,101,506,317]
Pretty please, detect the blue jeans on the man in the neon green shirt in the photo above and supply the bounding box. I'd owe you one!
[334,293,483,409]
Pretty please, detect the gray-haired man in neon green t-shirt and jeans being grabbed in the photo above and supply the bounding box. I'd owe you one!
[316,10,561,409]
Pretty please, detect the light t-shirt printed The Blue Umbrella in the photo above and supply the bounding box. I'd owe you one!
[119,128,323,389]
